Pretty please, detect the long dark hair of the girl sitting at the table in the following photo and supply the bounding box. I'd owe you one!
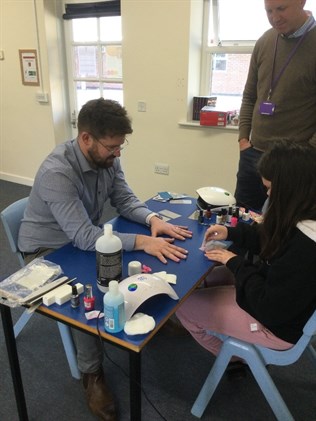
[258,140,316,259]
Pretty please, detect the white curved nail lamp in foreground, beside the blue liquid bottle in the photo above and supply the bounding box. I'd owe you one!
[119,273,179,320]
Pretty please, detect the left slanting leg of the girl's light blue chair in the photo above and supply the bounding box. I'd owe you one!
[191,345,231,418]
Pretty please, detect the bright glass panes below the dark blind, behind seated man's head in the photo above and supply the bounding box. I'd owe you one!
[71,16,123,109]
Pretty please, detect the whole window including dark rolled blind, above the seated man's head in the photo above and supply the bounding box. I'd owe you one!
[63,0,123,129]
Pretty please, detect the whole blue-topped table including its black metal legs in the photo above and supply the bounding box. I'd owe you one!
[1,199,218,421]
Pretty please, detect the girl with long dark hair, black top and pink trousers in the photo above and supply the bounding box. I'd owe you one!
[177,141,316,364]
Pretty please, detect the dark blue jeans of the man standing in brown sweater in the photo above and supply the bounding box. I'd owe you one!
[235,147,267,211]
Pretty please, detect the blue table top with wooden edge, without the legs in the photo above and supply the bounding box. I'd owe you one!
[39,199,217,352]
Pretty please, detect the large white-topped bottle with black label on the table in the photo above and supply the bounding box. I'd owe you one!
[95,224,123,292]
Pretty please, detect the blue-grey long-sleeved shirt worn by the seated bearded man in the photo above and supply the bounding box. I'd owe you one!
[18,139,151,252]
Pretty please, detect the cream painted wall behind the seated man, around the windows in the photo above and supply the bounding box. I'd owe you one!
[0,0,238,199]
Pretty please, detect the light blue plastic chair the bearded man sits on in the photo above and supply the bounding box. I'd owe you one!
[1,197,81,380]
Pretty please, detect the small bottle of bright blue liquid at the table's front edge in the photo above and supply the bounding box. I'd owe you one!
[103,281,126,333]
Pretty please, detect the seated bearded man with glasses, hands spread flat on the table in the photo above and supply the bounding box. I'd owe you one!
[18,98,192,421]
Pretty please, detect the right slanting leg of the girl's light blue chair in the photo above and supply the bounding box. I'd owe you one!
[247,357,294,421]
